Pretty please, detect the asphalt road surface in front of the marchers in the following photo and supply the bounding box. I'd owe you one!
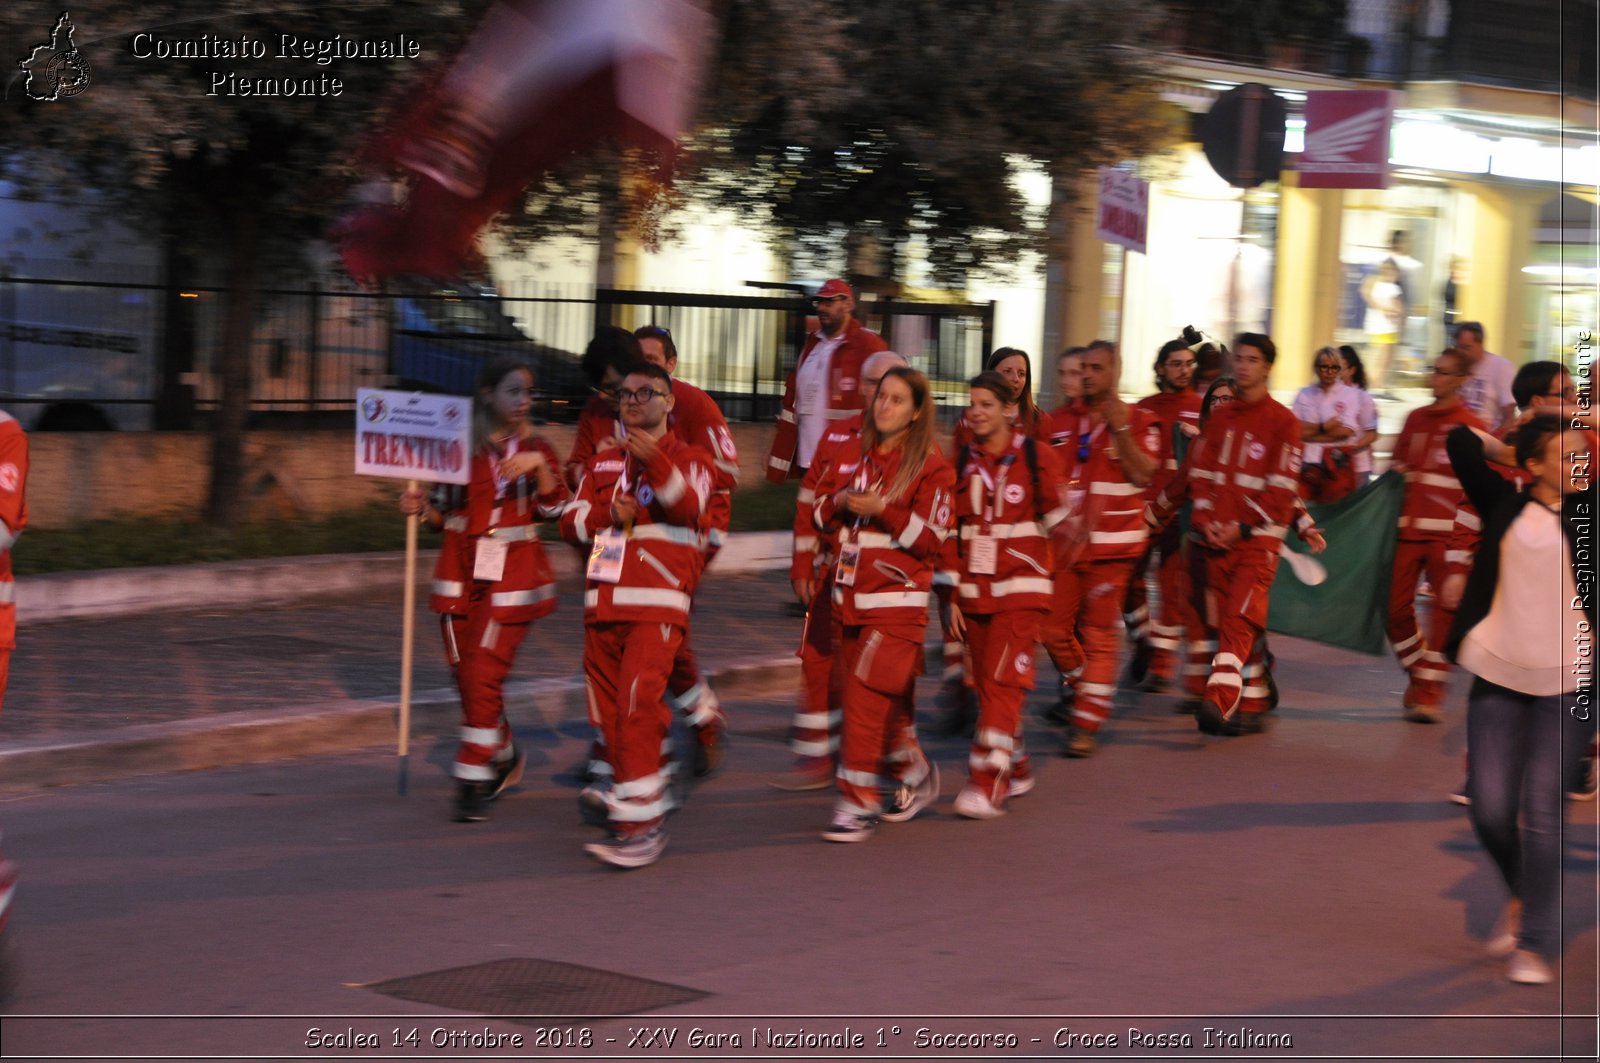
[0,639,1600,1060]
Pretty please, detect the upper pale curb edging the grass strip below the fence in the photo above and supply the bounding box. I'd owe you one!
[16,532,794,628]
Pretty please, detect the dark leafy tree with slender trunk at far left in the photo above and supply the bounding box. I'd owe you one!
[0,0,486,527]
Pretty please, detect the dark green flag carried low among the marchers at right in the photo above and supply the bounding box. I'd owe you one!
[1267,472,1405,656]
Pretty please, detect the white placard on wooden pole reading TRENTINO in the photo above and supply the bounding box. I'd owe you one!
[355,387,472,483]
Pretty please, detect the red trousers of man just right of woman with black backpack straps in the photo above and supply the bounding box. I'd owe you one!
[1054,557,1139,735]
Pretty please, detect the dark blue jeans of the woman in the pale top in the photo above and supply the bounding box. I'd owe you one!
[1467,677,1594,956]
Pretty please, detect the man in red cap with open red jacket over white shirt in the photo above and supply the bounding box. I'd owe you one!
[766,277,888,483]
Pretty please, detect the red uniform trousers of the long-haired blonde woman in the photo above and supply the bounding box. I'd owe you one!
[835,623,933,816]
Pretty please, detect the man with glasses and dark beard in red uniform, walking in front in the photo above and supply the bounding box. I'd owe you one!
[562,363,715,868]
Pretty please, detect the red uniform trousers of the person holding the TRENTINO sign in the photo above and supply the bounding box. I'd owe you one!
[454,580,531,783]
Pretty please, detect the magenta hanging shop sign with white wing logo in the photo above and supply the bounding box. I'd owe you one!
[1298,90,1395,189]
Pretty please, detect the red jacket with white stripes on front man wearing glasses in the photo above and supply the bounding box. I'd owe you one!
[562,432,715,628]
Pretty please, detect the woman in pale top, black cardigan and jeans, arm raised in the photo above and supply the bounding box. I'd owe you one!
[1442,415,1595,985]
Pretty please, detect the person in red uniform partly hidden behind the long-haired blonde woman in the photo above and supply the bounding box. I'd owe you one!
[771,351,906,791]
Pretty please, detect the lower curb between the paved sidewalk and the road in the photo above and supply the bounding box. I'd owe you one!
[0,656,800,792]
